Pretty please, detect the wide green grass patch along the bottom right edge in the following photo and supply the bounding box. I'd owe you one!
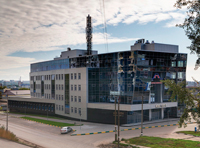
[124,136,200,148]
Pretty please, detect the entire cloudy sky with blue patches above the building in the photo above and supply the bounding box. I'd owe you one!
[0,0,200,81]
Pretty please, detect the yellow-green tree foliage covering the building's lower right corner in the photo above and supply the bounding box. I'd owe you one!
[163,80,200,129]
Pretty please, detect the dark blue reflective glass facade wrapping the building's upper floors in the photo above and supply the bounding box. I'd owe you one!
[31,50,187,105]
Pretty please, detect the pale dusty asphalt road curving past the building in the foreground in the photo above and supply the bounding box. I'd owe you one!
[0,115,198,148]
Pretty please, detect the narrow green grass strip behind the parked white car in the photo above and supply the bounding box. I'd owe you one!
[21,117,75,127]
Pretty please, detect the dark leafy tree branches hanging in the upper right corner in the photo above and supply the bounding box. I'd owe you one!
[174,0,200,70]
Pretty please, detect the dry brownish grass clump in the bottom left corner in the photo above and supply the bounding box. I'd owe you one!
[0,126,18,142]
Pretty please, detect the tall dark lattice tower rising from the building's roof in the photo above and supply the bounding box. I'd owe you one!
[86,14,92,55]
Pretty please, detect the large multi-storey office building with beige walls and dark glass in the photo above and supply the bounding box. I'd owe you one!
[9,39,187,124]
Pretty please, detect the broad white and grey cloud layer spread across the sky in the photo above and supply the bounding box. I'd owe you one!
[0,0,184,75]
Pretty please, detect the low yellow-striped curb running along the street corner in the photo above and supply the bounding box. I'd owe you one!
[71,122,196,136]
